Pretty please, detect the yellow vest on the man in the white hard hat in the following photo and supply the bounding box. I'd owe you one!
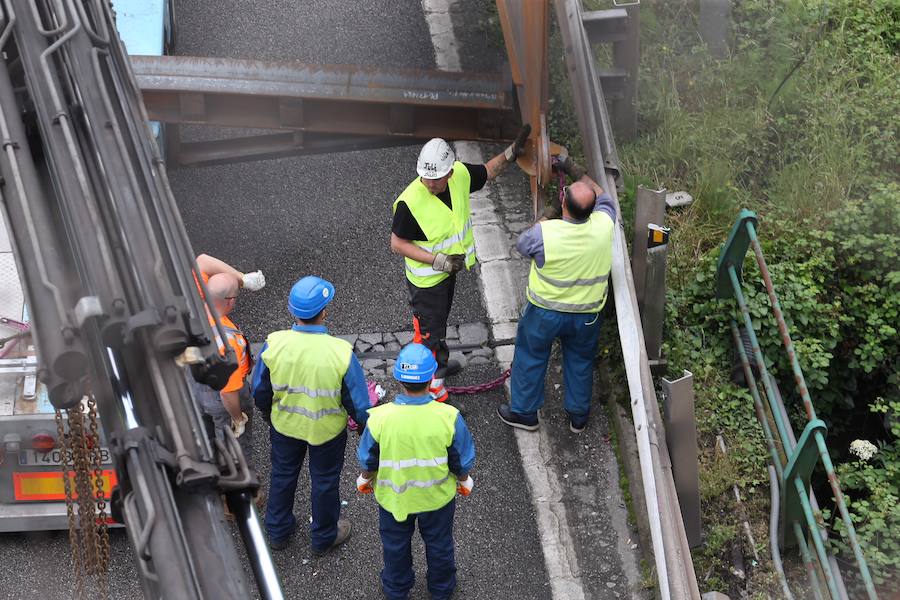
[393,161,475,288]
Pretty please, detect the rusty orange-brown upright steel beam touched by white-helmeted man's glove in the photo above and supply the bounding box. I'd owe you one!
[497,0,551,217]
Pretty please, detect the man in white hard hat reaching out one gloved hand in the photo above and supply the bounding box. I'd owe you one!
[391,124,531,402]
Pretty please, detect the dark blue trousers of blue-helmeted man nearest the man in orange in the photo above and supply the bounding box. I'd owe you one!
[265,427,347,551]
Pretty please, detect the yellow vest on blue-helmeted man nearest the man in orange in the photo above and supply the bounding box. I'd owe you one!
[262,330,353,446]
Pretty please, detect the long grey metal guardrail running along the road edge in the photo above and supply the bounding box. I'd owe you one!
[554,0,700,599]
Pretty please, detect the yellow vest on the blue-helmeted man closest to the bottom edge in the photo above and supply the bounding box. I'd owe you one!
[366,401,459,521]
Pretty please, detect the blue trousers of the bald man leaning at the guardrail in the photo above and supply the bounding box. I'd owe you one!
[510,302,601,420]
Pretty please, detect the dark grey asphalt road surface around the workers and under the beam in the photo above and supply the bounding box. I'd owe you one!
[0,0,549,599]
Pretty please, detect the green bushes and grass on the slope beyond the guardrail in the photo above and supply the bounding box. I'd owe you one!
[600,0,900,595]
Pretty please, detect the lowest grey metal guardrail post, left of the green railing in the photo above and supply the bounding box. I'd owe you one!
[662,371,703,548]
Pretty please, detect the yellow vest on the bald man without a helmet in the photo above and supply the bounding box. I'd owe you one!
[526,211,613,313]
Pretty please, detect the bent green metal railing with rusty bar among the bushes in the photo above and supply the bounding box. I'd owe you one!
[716,210,878,600]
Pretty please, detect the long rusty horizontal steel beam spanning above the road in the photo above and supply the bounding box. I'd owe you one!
[131,56,519,143]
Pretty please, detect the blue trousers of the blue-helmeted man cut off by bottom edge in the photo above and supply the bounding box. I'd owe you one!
[378,500,456,600]
